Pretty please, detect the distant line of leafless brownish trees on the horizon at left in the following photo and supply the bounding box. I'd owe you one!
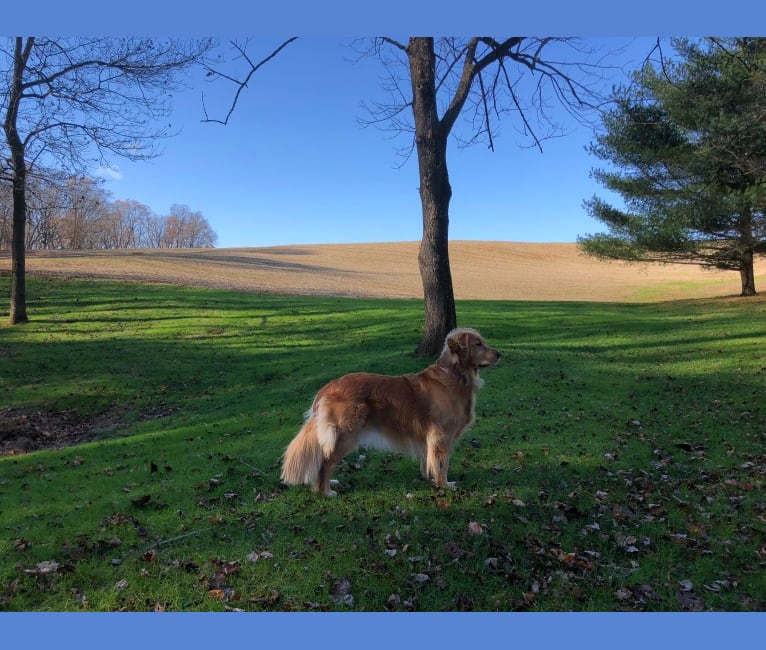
[0,173,218,250]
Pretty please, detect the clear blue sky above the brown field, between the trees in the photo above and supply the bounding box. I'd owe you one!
[94,37,652,247]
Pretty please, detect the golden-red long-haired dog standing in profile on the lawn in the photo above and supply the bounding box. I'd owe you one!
[282,328,500,497]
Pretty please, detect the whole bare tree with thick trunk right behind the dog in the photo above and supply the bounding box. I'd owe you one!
[357,36,604,355]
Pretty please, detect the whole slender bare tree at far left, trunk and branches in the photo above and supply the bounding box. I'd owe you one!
[0,36,213,324]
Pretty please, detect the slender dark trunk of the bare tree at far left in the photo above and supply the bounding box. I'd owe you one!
[3,38,33,325]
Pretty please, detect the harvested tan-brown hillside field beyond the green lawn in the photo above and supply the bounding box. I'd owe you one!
[0,241,766,302]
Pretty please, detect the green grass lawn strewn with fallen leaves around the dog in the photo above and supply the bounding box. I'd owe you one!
[0,277,766,611]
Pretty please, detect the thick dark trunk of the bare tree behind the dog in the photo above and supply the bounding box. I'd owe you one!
[407,38,457,356]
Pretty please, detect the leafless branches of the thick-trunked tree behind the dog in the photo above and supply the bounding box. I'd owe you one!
[357,36,617,156]
